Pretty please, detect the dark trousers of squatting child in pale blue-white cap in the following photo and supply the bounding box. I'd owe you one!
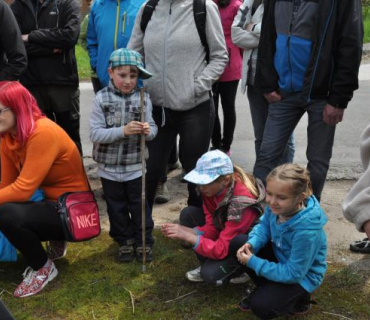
[180,207,244,285]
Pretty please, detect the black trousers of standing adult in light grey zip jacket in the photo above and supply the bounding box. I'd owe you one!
[146,100,214,208]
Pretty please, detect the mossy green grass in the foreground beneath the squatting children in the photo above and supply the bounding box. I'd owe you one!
[0,230,370,320]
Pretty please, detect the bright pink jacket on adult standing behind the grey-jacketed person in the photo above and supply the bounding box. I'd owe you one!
[214,0,243,82]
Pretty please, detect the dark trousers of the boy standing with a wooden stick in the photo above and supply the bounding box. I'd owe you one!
[101,177,154,246]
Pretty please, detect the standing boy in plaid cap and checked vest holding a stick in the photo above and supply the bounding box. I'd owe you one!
[90,49,157,262]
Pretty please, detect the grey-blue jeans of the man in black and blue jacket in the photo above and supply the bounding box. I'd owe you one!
[253,93,335,201]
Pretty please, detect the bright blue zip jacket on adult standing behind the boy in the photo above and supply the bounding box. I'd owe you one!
[86,0,146,87]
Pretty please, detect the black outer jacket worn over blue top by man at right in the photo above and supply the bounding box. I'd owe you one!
[256,0,363,108]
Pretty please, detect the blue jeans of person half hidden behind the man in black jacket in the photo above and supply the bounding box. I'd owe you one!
[247,85,295,164]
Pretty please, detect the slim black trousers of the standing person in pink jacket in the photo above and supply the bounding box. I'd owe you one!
[212,80,239,151]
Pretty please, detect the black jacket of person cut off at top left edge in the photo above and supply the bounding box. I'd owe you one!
[0,0,27,81]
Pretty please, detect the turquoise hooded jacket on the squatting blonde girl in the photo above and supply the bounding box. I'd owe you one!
[247,196,327,292]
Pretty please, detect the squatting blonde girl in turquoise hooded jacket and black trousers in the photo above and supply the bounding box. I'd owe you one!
[230,164,327,319]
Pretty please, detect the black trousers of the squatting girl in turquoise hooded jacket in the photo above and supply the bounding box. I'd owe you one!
[229,235,310,319]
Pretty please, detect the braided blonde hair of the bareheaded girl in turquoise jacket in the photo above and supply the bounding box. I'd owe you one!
[266,163,313,198]
